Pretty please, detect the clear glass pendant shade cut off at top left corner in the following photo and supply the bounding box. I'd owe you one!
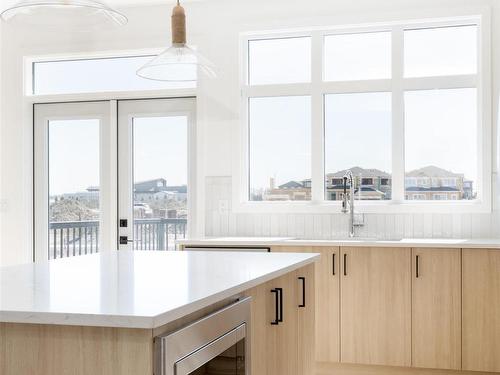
[1,0,128,31]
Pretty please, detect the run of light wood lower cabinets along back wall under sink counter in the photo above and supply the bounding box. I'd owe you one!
[268,247,500,375]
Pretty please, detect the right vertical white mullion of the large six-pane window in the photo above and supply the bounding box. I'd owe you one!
[392,26,405,202]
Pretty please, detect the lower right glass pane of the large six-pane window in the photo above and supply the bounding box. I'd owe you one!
[405,89,478,200]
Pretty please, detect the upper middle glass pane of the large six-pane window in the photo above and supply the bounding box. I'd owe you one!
[324,32,392,81]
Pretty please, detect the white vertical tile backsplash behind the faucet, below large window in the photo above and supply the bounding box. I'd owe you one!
[205,177,500,239]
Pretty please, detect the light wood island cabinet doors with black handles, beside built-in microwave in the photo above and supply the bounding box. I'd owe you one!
[246,265,315,375]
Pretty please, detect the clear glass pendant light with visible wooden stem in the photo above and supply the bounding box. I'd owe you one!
[137,0,215,82]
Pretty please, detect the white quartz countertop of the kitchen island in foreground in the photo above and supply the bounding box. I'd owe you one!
[0,251,318,328]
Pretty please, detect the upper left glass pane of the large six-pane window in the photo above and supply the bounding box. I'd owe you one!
[248,37,311,85]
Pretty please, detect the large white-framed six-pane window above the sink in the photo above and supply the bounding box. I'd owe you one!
[240,16,491,212]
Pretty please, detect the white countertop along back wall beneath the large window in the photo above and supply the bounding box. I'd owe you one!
[177,237,500,249]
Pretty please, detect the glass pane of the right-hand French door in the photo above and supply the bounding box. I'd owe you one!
[133,116,188,250]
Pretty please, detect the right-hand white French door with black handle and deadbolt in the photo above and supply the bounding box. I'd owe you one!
[118,99,196,250]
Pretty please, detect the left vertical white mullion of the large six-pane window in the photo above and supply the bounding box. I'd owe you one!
[311,33,325,201]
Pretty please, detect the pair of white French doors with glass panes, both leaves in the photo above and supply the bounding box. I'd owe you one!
[33,98,196,261]
